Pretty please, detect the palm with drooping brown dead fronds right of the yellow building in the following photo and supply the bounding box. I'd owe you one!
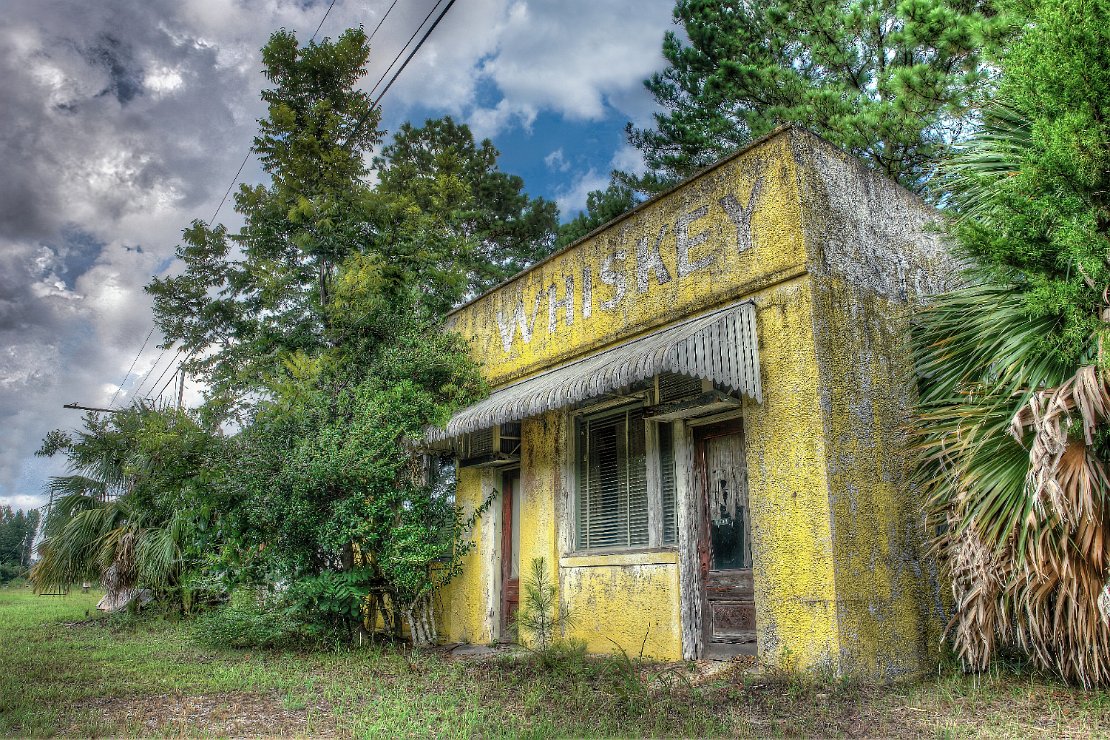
[916,101,1110,686]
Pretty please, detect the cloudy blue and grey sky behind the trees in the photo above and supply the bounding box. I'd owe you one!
[0,0,674,507]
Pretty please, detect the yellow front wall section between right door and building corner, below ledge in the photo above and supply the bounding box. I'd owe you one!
[744,275,839,670]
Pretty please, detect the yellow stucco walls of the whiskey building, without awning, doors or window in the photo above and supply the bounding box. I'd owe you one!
[441,130,951,676]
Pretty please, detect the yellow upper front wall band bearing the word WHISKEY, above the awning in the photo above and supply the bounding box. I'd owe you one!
[451,128,806,386]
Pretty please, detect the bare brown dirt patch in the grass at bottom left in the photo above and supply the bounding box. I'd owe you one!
[64,692,340,738]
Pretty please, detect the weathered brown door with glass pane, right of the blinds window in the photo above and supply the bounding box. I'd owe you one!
[694,420,756,658]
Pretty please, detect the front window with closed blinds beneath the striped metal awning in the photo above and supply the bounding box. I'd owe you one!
[576,407,677,550]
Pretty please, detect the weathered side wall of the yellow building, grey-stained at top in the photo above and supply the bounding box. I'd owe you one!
[795,132,955,678]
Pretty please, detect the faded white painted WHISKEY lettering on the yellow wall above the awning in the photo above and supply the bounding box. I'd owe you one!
[496,178,763,352]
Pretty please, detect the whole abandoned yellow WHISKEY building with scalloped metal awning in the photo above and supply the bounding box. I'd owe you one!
[428,128,953,677]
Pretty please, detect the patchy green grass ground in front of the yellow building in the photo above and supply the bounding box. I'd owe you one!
[0,588,1110,738]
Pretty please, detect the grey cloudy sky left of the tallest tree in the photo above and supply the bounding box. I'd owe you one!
[0,1,266,510]
